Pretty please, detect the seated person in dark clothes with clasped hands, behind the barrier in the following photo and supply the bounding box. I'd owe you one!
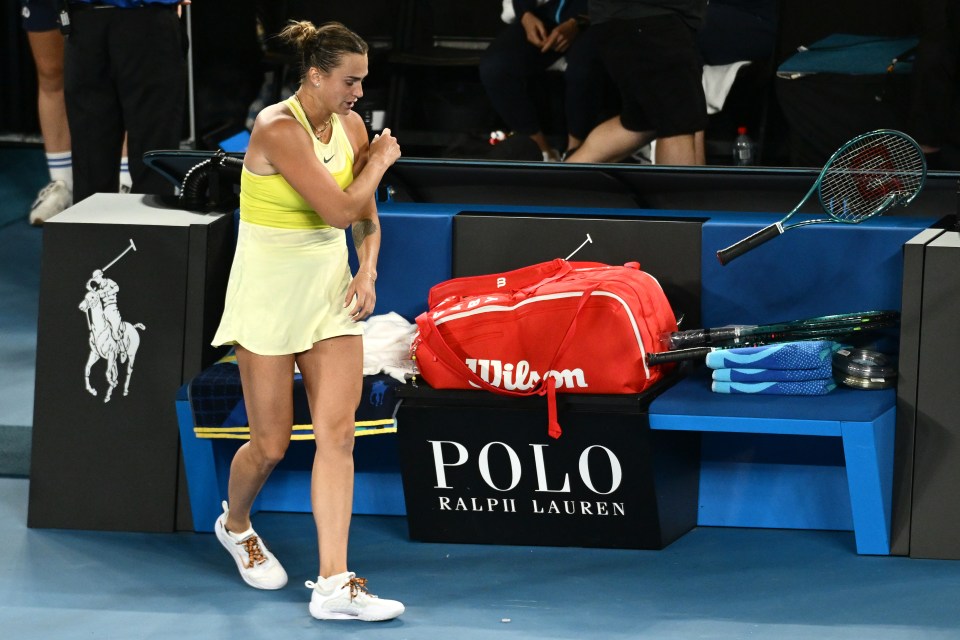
[480,0,605,161]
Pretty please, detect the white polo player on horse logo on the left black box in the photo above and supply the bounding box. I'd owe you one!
[79,239,146,402]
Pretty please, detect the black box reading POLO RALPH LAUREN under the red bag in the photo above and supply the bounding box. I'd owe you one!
[398,387,699,549]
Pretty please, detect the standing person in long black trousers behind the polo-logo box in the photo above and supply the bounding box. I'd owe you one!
[64,0,187,202]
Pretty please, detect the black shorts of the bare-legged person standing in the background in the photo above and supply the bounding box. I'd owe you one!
[593,15,707,138]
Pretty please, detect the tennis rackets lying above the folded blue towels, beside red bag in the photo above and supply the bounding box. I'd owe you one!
[647,311,900,365]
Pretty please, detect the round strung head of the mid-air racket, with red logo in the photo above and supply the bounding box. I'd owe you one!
[820,132,926,222]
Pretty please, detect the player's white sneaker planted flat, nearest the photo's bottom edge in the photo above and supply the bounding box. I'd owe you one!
[304,571,404,622]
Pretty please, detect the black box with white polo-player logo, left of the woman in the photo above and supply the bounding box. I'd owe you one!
[28,202,229,531]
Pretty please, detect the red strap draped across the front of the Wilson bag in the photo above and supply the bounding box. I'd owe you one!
[417,282,600,438]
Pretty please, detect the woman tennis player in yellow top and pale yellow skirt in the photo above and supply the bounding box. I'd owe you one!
[213,21,404,621]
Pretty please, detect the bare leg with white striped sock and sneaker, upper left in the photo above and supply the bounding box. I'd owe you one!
[21,0,73,225]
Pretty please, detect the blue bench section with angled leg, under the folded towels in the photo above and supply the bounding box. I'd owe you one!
[650,370,896,555]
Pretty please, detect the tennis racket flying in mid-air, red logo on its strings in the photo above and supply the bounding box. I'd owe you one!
[717,129,927,265]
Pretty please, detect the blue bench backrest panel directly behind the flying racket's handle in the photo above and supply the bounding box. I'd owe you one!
[690,214,935,328]
